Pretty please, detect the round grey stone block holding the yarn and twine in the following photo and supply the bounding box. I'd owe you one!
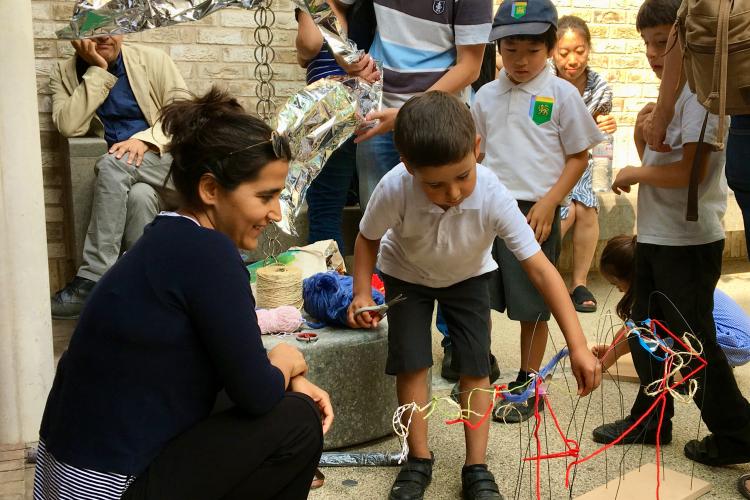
[263,321,398,450]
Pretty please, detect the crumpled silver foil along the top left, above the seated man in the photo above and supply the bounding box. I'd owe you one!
[54,0,257,40]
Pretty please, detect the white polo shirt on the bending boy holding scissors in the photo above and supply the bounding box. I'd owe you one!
[359,163,540,288]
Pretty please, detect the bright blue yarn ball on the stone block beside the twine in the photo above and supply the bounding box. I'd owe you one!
[302,271,385,326]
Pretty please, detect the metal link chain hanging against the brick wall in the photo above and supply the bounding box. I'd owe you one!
[253,0,276,122]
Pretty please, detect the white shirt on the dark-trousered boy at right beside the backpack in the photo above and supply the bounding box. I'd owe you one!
[637,84,729,246]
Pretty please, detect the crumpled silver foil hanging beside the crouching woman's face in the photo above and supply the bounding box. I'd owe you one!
[276,76,383,235]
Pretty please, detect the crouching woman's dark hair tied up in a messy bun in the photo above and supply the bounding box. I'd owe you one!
[161,87,291,207]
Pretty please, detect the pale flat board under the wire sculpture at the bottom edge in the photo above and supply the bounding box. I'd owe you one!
[576,463,711,500]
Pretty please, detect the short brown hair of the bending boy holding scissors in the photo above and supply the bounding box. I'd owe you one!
[393,90,477,168]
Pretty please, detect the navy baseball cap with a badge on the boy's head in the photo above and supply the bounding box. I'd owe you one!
[488,0,557,42]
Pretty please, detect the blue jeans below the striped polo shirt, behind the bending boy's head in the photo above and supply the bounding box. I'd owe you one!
[357,132,401,210]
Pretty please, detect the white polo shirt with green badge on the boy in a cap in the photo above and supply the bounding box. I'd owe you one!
[471,70,605,202]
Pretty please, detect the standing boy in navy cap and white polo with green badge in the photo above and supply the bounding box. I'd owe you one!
[471,0,604,423]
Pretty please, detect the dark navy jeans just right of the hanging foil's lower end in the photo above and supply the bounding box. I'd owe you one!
[307,138,357,255]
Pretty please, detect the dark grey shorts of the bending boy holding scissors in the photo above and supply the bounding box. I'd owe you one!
[383,273,492,377]
